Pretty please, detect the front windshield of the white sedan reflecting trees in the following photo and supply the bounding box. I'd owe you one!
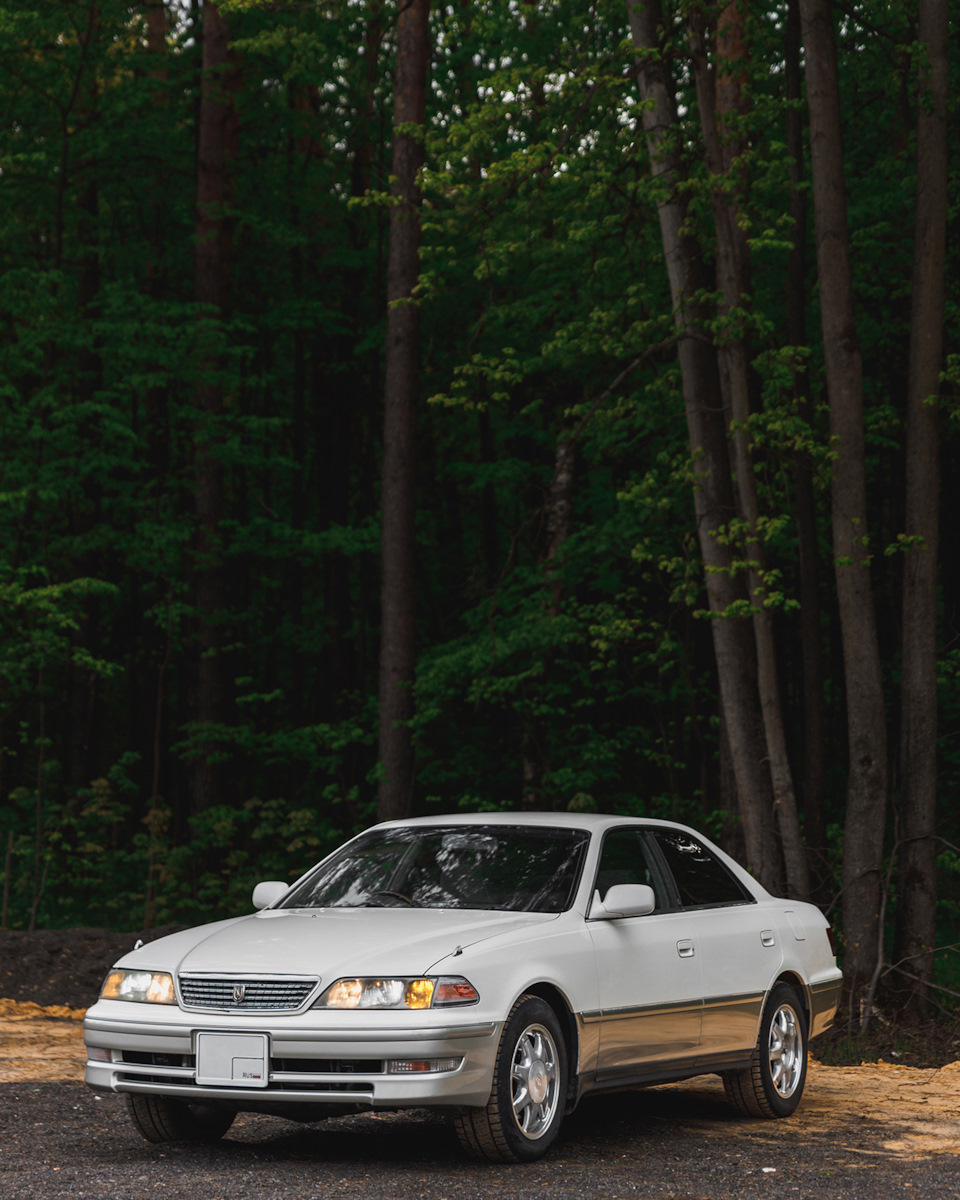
[280,826,588,912]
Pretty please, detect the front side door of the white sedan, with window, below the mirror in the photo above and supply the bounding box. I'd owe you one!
[588,827,702,1081]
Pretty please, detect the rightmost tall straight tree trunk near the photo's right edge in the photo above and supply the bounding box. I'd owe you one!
[898,0,949,1012]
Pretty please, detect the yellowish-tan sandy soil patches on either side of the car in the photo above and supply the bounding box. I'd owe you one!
[0,1000,960,1159]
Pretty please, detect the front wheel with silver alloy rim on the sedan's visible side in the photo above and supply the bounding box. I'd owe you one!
[455,996,568,1163]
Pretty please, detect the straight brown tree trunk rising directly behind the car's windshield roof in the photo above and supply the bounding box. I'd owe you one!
[377,0,430,821]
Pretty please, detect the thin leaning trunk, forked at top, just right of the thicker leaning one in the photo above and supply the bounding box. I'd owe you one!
[689,2,810,900]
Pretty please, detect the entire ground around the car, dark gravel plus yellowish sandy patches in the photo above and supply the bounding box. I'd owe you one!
[0,930,960,1200]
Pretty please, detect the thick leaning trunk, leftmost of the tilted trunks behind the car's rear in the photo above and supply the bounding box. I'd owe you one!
[628,0,780,889]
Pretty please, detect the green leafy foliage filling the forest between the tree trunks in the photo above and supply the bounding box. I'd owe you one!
[0,0,960,993]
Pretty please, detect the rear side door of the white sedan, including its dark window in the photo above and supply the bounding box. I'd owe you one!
[652,829,784,1063]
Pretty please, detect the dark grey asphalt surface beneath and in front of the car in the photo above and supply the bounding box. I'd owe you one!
[0,1080,960,1200]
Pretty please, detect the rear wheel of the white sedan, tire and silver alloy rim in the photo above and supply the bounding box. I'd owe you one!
[722,983,806,1117]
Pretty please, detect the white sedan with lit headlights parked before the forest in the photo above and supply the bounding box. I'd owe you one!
[84,812,841,1162]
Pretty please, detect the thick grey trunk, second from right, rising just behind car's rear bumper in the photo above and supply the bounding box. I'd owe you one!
[800,0,887,1001]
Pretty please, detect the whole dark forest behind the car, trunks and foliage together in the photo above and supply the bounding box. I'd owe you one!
[0,0,960,1032]
